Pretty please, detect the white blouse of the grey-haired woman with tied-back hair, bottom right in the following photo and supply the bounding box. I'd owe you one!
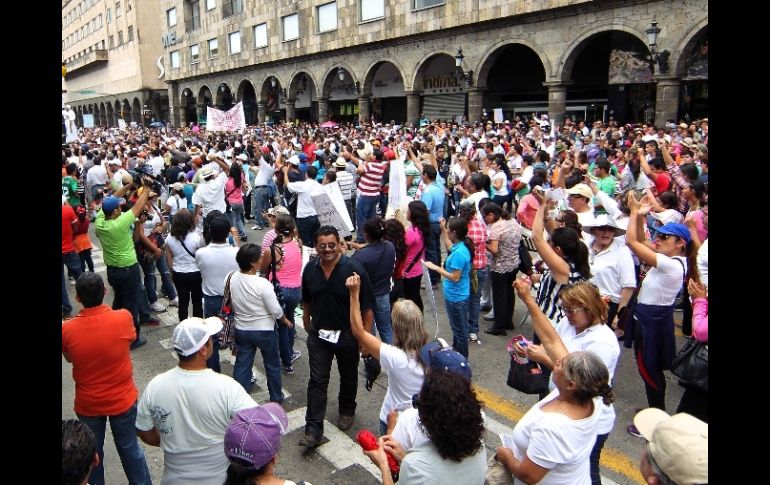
[513,390,604,485]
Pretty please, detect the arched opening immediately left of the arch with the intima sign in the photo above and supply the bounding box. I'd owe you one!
[362,61,406,124]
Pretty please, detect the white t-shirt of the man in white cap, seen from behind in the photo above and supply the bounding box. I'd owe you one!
[136,367,257,485]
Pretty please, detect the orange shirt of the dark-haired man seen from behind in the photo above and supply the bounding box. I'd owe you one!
[61,305,138,416]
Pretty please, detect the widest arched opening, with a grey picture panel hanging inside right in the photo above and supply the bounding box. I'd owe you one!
[562,30,655,124]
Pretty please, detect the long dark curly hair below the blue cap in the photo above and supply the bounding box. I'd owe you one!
[417,370,484,462]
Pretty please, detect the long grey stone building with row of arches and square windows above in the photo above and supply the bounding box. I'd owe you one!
[159,0,708,125]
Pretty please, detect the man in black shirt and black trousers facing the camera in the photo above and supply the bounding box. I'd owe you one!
[299,226,375,448]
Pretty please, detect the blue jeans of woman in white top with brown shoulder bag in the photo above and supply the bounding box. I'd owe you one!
[233,328,283,402]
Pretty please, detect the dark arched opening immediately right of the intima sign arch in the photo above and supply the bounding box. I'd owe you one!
[477,44,548,120]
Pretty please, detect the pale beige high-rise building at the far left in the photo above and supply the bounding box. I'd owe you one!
[62,0,169,126]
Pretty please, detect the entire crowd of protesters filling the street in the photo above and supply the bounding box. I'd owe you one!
[62,116,708,485]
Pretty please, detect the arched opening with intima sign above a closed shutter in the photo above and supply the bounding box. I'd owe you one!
[414,53,467,121]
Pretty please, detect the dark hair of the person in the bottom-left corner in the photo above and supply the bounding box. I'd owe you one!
[61,419,96,485]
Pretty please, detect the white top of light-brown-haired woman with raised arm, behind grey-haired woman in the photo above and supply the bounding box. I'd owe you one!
[548,317,620,434]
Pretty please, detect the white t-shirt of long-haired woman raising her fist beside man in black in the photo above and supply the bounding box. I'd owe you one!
[380,342,425,423]
